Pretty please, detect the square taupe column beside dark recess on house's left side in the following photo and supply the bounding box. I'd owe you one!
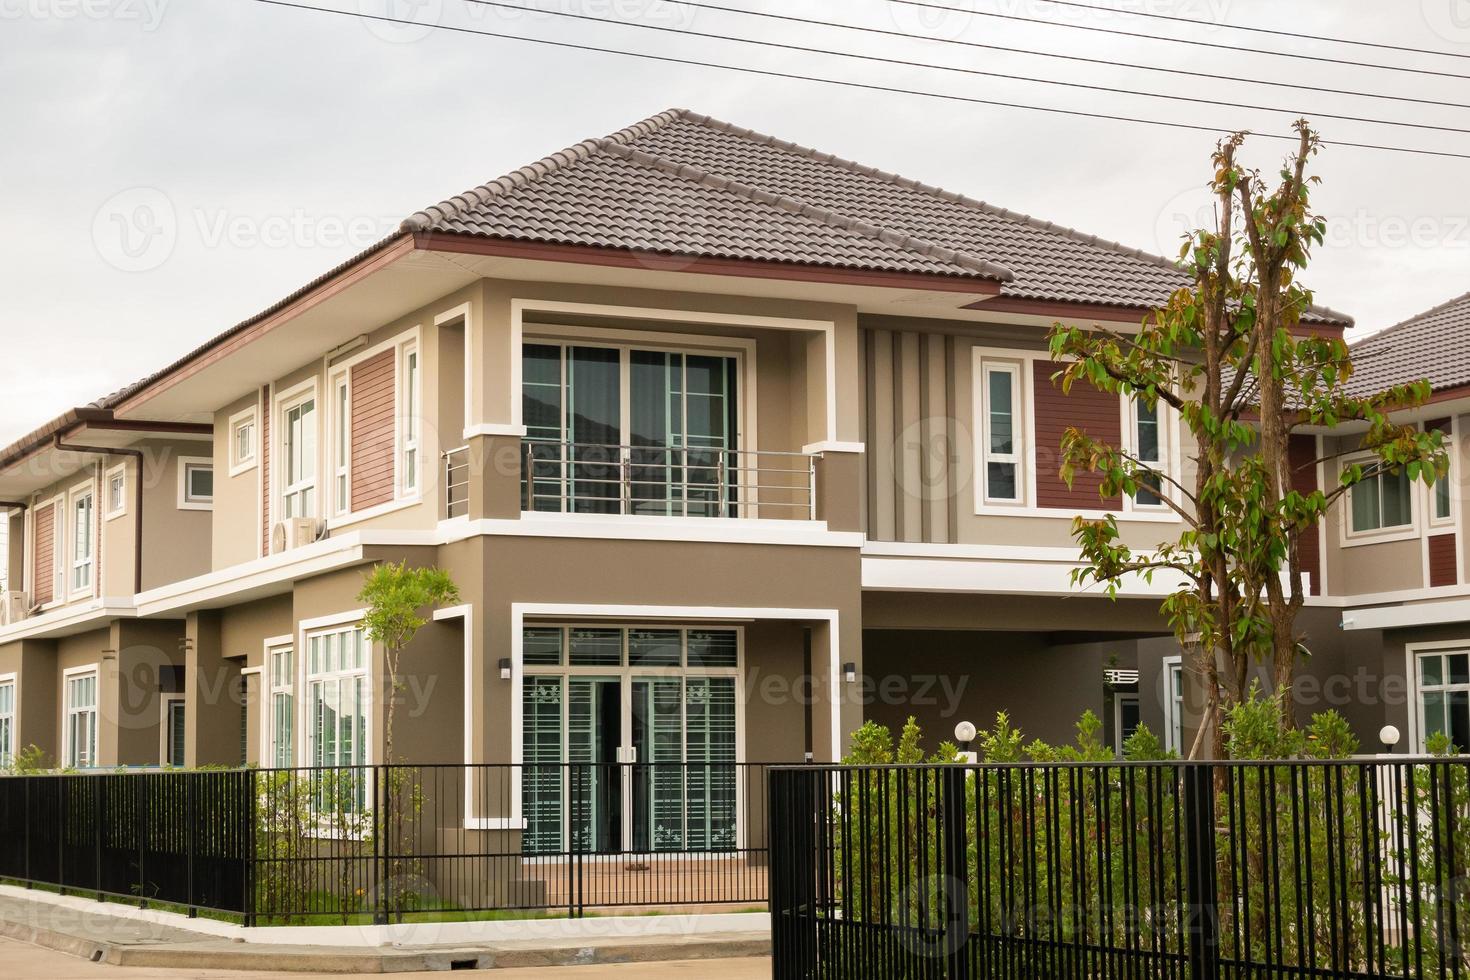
[184,610,240,768]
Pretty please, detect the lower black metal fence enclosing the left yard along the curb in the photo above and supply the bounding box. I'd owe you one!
[0,763,767,924]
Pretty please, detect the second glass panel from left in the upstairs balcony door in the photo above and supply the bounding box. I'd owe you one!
[566,347,623,514]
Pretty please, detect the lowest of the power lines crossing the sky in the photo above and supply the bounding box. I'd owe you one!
[256,0,1470,160]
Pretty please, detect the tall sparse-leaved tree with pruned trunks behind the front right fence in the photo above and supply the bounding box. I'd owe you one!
[1050,120,1448,758]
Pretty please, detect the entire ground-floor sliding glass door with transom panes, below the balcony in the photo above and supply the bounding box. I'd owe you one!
[522,626,742,854]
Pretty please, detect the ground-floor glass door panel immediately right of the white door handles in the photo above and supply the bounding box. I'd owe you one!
[632,677,684,852]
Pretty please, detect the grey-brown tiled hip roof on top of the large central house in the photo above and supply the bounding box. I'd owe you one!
[404,109,1351,322]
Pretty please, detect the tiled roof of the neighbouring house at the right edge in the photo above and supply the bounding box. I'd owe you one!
[1348,292,1470,394]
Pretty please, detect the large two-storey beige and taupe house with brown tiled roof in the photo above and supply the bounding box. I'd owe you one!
[0,110,1463,808]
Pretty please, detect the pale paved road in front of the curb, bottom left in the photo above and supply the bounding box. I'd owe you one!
[0,937,770,980]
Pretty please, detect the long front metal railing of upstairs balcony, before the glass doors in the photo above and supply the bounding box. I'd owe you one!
[520,439,816,520]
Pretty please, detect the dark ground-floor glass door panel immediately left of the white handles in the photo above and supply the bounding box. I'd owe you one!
[566,677,623,854]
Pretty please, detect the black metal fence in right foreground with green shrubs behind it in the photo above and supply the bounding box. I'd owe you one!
[769,758,1470,980]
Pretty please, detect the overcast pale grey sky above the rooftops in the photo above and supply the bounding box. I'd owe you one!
[0,0,1470,444]
